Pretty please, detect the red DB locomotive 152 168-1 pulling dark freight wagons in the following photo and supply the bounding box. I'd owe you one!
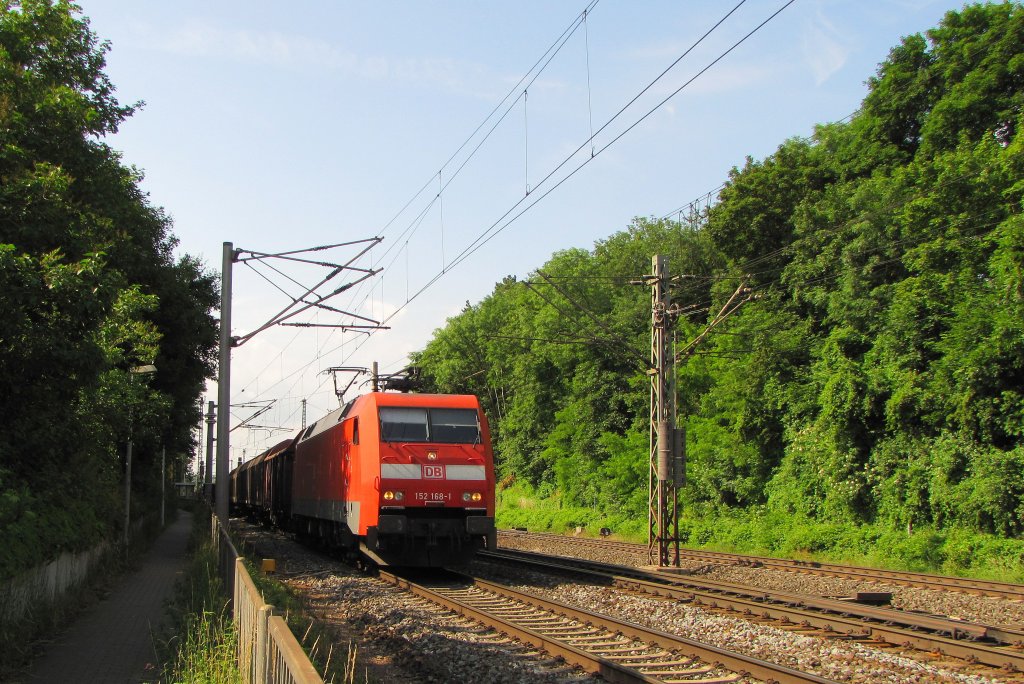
[230,392,497,567]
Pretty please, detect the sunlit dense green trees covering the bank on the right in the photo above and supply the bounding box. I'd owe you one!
[417,3,1024,573]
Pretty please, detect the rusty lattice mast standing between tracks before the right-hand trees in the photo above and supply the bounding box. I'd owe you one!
[644,255,685,567]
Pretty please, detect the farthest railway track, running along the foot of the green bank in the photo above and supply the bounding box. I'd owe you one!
[499,529,1024,601]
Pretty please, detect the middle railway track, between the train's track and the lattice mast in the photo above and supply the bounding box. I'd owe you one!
[480,550,1024,673]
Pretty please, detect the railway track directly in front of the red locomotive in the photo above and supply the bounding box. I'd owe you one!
[379,570,833,684]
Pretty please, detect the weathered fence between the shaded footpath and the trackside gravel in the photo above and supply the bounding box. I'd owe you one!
[212,516,324,684]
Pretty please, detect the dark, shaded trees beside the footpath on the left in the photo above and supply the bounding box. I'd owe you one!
[0,0,217,576]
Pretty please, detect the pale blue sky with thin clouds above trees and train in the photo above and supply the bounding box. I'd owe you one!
[74,0,961,466]
